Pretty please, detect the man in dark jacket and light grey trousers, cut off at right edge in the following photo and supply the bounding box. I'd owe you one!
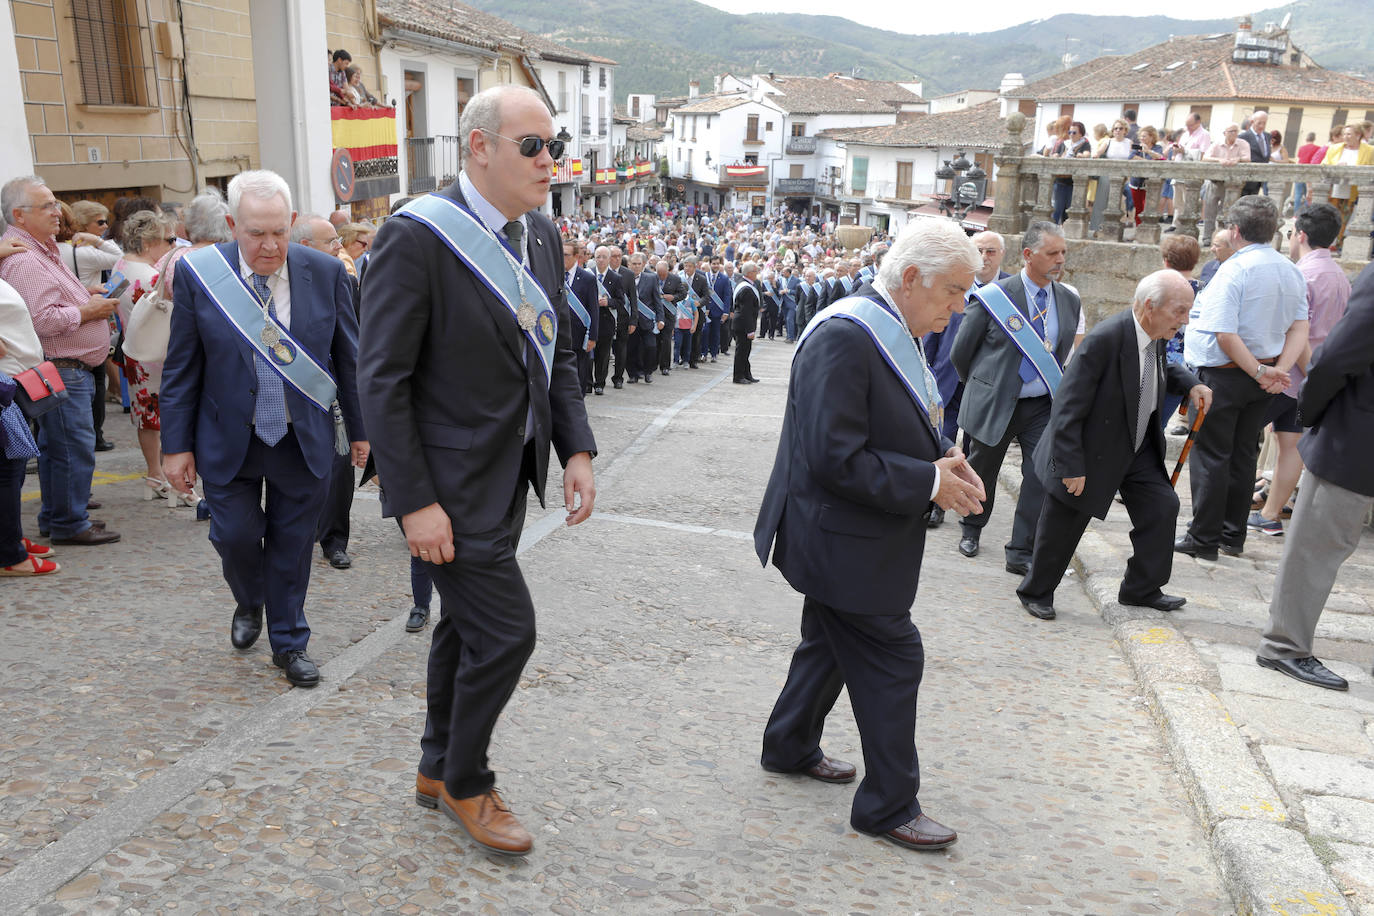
[1254,258,1374,691]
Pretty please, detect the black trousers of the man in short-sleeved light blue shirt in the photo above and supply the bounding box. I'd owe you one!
[1189,367,1274,548]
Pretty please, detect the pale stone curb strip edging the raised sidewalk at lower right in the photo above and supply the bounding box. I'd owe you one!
[998,463,1352,916]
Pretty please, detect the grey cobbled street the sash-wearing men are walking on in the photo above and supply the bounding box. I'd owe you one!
[0,342,1236,916]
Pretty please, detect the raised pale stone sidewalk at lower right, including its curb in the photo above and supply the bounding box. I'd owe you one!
[1000,437,1374,916]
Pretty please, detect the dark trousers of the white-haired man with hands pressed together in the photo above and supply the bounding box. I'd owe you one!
[761,597,926,834]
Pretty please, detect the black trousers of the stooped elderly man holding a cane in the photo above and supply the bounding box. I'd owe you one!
[1017,435,1179,604]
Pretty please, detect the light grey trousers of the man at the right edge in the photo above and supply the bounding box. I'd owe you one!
[1259,471,1374,658]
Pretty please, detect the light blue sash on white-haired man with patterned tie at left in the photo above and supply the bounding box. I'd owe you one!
[181,244,338,413]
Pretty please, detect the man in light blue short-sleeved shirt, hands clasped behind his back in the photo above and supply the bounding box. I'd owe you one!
[1173,195,1308,560]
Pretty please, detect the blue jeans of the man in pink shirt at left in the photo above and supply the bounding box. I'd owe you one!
[38,368,95,537]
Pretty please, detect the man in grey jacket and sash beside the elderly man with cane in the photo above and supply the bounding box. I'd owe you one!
[949,220,1083,575]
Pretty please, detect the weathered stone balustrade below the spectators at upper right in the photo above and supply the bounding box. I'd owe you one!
[989,118,1374,264]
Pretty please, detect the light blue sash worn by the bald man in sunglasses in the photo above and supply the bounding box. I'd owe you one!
[396,194,558,386]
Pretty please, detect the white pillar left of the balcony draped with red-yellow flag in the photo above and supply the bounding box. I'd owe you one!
[249,0,335,213]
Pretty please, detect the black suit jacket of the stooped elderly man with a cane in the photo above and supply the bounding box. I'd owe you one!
[1033,309,1198,518]
